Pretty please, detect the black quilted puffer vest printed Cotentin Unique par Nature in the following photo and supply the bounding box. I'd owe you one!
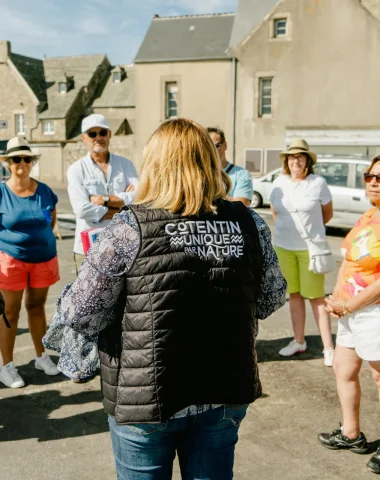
[99,201,262,424]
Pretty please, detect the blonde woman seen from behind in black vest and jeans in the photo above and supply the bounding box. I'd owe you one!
[43,119,286,480]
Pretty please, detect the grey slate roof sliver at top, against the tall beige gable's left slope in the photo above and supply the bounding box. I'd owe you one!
[229,0,279,48]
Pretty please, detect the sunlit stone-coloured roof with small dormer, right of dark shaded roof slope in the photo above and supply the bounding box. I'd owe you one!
[40,54,106,119]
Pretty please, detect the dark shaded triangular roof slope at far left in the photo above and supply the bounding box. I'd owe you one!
[10,52,47,108]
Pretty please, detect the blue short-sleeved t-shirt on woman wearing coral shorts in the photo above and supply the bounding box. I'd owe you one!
[0,182,58,263]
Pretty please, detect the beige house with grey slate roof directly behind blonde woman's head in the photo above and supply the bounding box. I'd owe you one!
[135,14,236,171]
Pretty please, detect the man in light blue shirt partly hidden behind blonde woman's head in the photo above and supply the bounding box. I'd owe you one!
[207,127,253,207]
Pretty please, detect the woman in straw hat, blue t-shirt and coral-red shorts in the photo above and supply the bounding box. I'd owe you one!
[0,137,59,388]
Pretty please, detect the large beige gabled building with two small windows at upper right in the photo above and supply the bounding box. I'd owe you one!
[229,0,380,173]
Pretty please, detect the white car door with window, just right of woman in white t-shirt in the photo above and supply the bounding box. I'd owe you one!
[314,160,350,227]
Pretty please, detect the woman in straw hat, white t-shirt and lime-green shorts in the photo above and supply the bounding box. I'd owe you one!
[269,139,334,367]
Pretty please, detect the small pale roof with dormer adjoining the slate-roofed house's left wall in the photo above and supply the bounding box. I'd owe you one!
[92,65,136,108]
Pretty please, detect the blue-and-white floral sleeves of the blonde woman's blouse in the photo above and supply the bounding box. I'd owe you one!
[43,209,286,388]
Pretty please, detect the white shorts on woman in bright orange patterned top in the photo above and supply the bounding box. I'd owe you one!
[336,305,380,362]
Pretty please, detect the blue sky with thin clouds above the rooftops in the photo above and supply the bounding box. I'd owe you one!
[0,0,238,65]
